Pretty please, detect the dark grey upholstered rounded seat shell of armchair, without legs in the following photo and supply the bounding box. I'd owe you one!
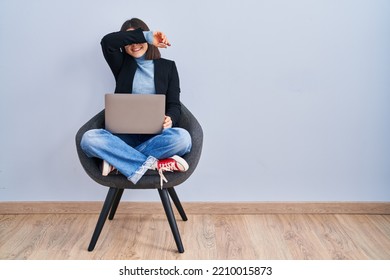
[76,104,203,189]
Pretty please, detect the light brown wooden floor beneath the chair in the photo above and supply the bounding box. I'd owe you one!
[0,213,390,260]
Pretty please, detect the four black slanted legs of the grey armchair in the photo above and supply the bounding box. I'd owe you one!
[88,187,187,253]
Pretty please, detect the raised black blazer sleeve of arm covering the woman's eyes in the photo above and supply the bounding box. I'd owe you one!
[100,28,146,80]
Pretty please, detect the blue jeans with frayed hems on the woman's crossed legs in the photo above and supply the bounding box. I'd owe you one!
[80,127,192,184]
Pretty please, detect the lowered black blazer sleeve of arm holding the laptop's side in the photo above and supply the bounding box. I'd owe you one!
[166,61,181,126]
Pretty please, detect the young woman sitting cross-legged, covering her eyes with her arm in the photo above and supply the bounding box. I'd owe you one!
[81,18,191,186]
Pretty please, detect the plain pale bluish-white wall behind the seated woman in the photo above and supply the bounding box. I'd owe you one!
[0,0,390,201]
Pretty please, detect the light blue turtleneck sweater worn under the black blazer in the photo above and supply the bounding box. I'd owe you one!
[133,31,156,94]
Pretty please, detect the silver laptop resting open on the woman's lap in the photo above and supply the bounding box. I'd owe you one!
[105,93,165,134]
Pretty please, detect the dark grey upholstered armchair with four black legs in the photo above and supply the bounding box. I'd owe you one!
[76,104,203,253]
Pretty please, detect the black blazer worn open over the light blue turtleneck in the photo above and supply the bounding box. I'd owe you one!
[101,29,181,126]
